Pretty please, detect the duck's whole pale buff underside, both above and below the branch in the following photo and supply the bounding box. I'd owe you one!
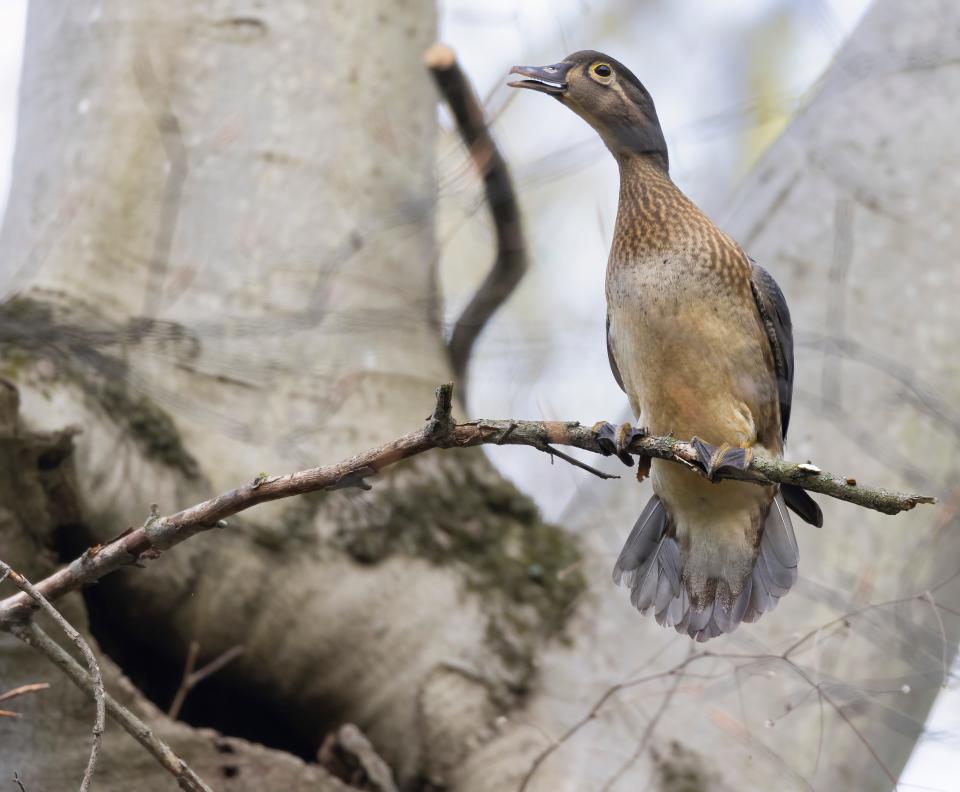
[607,258,780,593]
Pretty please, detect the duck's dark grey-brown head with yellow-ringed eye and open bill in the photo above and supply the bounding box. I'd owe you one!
[510,50,668,171]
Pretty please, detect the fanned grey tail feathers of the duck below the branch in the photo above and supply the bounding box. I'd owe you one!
[613,493,799,641]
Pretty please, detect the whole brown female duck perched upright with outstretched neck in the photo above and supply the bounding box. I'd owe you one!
[510,50,823,641]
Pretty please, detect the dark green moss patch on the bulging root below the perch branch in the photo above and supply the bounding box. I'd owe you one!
[333,452,585,687]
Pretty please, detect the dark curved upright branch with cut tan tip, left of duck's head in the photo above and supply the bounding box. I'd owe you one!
[423,42,527,386]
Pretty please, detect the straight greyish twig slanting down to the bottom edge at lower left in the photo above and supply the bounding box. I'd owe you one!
[10,621,213,792]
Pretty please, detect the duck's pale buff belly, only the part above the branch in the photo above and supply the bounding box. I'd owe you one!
[607,257,776,450]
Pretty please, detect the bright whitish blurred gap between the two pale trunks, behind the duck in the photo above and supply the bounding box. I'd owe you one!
[439,0,867,519]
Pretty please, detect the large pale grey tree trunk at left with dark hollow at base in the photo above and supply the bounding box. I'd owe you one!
[0,0,582,790]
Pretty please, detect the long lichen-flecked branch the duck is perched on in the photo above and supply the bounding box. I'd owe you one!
[0,384,936,628]
